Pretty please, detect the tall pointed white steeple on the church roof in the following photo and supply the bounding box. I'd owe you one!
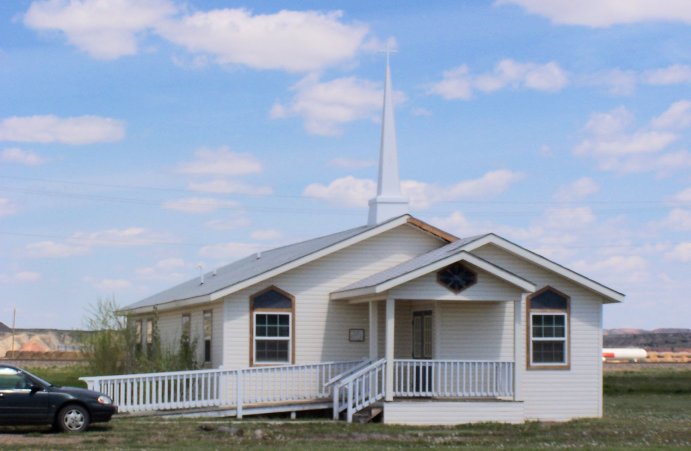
[368,51,408,225]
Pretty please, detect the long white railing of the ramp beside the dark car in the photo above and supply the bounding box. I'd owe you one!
[80,360,362,417]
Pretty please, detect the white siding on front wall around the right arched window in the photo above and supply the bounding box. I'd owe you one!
[473,244,603,421]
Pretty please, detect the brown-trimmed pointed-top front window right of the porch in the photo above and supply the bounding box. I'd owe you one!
[528,287,569,369]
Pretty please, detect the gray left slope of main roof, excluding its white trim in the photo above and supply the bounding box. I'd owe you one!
[123,222,384,311]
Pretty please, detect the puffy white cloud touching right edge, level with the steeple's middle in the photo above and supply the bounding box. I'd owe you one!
[573,101,691,175]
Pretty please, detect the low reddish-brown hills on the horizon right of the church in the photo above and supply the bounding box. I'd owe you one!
[603,328,691,352]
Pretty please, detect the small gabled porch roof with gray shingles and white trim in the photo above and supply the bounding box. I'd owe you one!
[331,242,537,300]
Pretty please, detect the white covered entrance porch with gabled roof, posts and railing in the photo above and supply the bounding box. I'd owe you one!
[331,252,535,424]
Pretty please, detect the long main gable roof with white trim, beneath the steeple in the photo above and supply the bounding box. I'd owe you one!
[122,215,456,313]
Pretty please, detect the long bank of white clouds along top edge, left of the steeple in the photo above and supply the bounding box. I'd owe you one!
[24,0,368,72]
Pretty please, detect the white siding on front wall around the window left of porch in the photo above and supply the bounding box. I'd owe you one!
[223,225,444,368]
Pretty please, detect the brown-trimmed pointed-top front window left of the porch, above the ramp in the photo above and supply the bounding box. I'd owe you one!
[250,287,294,364]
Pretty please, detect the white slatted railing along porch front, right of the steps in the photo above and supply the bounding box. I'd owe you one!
[393,359,514,398]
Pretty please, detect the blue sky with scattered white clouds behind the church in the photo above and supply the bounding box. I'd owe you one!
[0,0,691,328]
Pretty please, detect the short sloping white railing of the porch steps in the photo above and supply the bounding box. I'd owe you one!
[332,359,386,423]
